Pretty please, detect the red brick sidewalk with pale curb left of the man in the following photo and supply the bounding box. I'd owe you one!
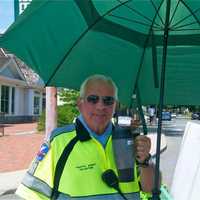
[0,123,44,195]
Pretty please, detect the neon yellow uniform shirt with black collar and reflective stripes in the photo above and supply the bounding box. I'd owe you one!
[16,121,140,200]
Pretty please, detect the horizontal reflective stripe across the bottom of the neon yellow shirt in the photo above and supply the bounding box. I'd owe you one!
[57,192,140,200]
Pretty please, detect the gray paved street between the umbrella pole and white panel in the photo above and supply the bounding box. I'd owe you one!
[0,119,197,200]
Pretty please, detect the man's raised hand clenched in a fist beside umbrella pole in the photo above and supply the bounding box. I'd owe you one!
[134,135,151,163]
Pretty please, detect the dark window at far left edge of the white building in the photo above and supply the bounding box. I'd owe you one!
[1,85,9,114]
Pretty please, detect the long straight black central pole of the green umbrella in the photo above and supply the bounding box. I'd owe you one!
[152,0,171,200]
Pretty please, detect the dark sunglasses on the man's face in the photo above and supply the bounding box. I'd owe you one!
[86,95,115,106]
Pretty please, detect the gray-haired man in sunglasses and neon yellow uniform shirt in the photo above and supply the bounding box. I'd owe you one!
[17,75,153,200]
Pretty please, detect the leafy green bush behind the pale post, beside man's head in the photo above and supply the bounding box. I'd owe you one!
[38,104,79,131]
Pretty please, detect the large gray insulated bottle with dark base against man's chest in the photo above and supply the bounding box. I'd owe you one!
[112,124,135,182]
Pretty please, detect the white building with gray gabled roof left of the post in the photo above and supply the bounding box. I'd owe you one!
[0,49,45,123]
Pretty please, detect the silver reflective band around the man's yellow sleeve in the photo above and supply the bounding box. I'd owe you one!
[22,173,52,197]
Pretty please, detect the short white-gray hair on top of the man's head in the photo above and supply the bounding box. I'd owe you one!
[80,74,118,100]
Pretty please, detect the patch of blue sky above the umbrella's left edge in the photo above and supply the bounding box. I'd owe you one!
[0,0,14,33]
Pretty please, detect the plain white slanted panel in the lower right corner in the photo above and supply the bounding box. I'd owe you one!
[171,122,200,200]
